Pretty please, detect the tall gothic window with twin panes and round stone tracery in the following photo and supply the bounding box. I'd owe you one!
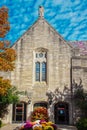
[35,51,47,82]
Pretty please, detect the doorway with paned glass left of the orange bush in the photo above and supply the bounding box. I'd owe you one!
[12,102,27,123]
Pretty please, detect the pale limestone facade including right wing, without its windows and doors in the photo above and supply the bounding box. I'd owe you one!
[1,6,87,124]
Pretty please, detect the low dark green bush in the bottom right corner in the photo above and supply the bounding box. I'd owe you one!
[76,118,87,130]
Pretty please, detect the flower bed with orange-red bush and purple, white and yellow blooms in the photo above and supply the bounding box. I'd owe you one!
[15,107,57,130]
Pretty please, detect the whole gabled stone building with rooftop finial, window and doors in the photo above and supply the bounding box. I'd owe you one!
[1,7,87,124]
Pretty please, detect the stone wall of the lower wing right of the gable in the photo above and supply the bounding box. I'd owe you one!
[72,56,87,89]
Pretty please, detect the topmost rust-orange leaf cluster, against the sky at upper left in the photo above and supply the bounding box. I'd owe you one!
[0,7,10,38]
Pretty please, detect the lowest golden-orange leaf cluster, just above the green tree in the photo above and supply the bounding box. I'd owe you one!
[0,77,11,96]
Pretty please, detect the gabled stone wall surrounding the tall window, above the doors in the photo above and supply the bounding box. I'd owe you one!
[11,18,71,104]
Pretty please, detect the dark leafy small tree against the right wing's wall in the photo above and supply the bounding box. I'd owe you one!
[73,79,87,118]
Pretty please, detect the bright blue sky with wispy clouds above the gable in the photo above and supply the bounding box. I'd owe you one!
[0,0,87,44]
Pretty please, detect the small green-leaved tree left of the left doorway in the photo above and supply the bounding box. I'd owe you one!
[0,83,19,118]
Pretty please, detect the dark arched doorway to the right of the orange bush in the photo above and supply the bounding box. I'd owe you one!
[54,102,69,124]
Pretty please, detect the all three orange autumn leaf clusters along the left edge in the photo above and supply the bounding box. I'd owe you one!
[0,7,16,96]
